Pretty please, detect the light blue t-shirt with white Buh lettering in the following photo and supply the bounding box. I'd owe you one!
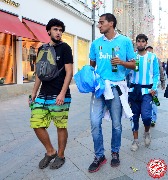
[89,34,134,82]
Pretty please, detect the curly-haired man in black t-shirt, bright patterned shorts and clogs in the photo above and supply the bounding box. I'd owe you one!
[30,19,73,169]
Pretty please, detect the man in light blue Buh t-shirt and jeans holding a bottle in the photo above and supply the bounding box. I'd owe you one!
[88,13,135,172]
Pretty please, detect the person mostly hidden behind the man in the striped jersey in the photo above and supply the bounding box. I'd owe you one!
[146,46,165,127]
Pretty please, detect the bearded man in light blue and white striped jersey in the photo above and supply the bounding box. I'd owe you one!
[129,34,159,151]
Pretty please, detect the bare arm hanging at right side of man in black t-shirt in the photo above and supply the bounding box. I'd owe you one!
[56,64,73,105]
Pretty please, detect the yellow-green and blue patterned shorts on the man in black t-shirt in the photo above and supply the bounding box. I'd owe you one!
[30,94,71,128]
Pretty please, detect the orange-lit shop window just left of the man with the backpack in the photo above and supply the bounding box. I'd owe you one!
[22,38,42,82]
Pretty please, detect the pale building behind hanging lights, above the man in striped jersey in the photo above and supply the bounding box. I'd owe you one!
[113,0,154,45]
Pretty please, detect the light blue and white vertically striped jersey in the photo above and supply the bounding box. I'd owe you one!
[129,52,160,95]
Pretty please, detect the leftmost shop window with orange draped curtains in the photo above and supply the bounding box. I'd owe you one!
[0,33,15,85]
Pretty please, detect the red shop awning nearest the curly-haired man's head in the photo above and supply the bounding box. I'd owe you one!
[22,18,50,43]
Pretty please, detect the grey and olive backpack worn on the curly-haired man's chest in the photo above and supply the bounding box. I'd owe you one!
[36,43,64,81]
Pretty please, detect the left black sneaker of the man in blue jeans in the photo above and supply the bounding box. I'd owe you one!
[88,156,107,173]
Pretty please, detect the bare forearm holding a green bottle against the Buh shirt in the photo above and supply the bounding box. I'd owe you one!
[111,57,135,69]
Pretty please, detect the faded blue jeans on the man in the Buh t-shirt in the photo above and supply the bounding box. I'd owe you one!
[90,88,122,158]
